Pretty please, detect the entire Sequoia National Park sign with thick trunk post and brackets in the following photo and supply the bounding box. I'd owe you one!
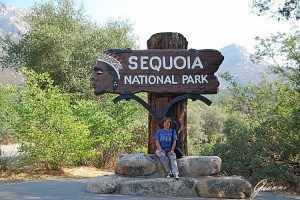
[91,33,224,155]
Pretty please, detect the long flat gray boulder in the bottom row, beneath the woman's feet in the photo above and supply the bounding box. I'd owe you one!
[120,178,197,197]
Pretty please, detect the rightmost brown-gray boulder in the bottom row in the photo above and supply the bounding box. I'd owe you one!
[196,176,253,199]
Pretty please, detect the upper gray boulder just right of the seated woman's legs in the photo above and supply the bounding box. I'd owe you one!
[178,156,221,178]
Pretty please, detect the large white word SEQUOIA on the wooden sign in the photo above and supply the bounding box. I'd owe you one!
[128,56,203,72]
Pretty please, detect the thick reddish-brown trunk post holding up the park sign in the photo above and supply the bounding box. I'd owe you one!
[147,32,188,155]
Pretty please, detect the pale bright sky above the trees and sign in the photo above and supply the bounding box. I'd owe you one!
[0,0,290,52]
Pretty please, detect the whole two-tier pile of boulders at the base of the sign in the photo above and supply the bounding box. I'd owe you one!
[87,153,253,199]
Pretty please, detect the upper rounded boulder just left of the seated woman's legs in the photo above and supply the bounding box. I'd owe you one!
[115,153,158,177]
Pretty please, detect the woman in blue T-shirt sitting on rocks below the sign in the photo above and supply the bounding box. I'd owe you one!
[155,117,179,179]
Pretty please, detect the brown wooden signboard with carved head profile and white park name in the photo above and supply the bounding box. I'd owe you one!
[91,49,224,95]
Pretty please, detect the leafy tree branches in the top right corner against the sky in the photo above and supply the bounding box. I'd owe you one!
[252,0,300,20]
